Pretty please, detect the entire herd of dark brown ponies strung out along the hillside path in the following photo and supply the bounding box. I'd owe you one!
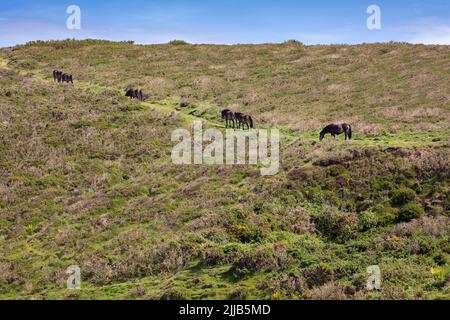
[49,70,352,141]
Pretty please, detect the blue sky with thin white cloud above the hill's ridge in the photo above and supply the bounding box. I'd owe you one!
[0,0,450,47]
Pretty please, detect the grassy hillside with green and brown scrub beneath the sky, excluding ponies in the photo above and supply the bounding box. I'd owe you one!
[0,41,450,299]
